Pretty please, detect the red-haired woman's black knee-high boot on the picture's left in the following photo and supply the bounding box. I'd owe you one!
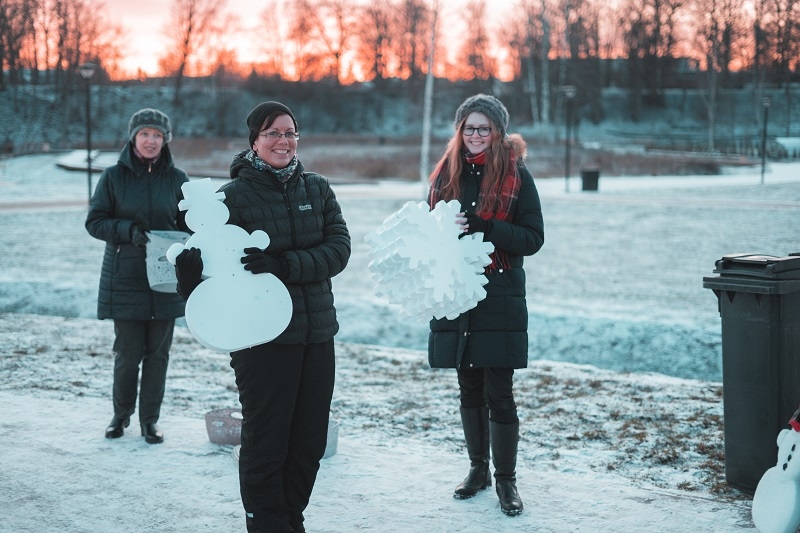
[453,407,492,499]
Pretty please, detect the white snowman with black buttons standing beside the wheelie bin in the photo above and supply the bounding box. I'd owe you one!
[752,416,800,533]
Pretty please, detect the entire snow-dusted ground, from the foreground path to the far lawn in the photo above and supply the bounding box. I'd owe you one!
[0,155,800,532]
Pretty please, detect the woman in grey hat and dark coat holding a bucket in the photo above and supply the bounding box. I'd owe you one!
[86,108,188,444]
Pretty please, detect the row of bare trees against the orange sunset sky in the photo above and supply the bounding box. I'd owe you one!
[0,0,800,146]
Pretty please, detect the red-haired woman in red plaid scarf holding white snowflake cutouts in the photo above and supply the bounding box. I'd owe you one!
[428,94,544,516]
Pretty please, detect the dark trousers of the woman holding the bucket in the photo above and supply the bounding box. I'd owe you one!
[113,319,175,424]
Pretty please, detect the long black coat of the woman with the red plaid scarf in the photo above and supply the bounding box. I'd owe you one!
[428,141,544,368]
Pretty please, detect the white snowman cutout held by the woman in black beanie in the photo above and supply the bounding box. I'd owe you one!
[166,178,292,352]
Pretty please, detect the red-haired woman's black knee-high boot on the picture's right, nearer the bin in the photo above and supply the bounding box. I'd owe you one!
[489,421,522,515]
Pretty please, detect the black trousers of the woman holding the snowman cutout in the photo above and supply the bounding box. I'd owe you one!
[231,339,335,533]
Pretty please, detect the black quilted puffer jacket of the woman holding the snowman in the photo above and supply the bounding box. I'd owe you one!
[220,150,350,344]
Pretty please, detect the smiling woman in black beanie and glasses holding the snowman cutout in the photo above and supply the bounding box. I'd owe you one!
[175,102,350,533]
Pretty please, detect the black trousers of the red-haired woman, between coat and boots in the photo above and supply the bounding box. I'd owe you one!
[458,368,519,424]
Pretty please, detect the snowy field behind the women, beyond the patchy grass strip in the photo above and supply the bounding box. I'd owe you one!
[0,155,800,380]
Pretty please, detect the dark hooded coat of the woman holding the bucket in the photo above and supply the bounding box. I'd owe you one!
[86,141,188,320]
